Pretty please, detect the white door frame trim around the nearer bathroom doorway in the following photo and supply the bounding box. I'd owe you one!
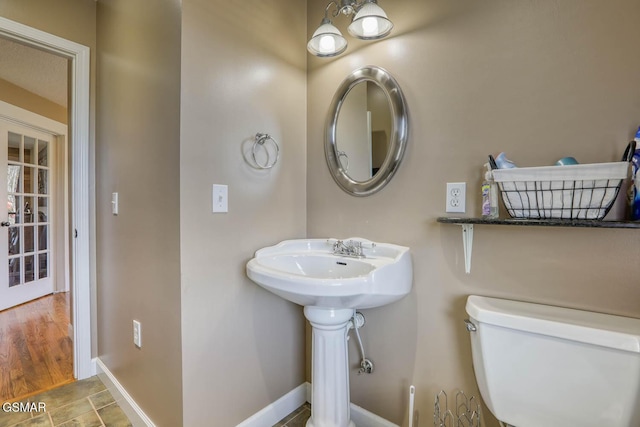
[0,17,95,380]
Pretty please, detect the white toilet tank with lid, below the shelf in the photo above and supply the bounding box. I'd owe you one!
[466,295,640,427]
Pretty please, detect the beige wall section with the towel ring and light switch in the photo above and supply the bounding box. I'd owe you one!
[180,0,306,426]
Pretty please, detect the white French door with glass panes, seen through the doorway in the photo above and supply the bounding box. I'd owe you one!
[0,119,55,310]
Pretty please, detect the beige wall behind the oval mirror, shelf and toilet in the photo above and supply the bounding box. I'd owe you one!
[307,0,640,427]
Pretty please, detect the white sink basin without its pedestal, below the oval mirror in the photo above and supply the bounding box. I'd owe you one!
[247,238,413,309]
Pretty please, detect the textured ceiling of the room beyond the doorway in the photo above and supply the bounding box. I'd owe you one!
[0,37,68,108]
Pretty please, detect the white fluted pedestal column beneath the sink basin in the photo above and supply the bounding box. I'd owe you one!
[304,307,355,427]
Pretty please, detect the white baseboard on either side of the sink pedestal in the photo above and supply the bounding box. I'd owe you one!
[236,382,399,427]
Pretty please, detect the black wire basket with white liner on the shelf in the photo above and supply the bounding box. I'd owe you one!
[489,142,635,220]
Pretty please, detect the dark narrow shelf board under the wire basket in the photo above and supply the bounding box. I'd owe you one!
[438,216,640,229]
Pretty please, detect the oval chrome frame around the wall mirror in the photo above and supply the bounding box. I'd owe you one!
[324,66,409,197]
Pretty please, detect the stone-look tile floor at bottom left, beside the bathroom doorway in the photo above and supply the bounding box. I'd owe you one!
[0,377,132,427]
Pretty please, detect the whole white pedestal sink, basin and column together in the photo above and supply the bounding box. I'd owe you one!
[247,238,413,427]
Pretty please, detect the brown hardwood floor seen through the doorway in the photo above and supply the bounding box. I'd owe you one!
[0,293,74,402]
